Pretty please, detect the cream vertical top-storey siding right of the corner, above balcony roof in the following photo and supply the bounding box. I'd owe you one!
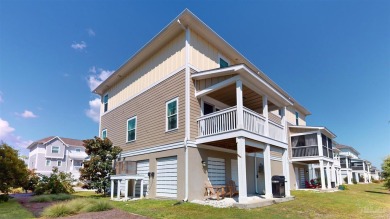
[190,31,233,71]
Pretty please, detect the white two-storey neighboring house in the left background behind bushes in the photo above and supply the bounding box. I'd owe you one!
[27,136,88,180]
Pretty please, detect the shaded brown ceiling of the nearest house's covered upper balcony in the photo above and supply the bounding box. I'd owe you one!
[207,84,278,114]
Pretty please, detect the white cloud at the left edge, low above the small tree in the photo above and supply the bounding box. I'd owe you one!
[0,118,33,152]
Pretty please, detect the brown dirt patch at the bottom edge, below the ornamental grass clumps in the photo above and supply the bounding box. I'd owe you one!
[61,209,147,219]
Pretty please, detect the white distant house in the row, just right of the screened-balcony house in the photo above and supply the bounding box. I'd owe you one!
[336,144,371,184]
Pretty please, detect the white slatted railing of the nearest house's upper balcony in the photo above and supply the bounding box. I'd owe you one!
[197,106,285,142]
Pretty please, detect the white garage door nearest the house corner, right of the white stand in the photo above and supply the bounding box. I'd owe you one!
[156,156,177,198]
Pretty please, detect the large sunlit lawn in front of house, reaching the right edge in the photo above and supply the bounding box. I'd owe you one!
[112,184,390,218]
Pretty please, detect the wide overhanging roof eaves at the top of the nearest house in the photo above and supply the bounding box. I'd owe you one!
[93,9,311,115]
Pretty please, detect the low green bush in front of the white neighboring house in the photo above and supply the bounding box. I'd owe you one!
[34,167,74,195]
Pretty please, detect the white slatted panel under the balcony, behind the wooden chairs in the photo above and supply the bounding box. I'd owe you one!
[207,157,226,186]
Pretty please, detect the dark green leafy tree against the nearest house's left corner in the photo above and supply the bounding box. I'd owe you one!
[80,137,122,193]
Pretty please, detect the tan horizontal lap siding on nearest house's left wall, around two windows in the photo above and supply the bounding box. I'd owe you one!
[101,70,185,152]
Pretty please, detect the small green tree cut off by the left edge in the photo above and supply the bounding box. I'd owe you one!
[0,142,28,194]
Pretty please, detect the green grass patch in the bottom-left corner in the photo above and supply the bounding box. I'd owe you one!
[0,199,34,219]
